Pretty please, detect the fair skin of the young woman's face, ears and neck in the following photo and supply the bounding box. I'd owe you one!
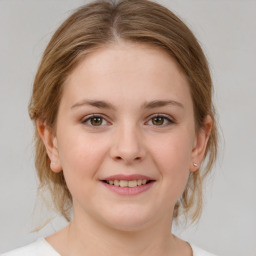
[37,42,211,256]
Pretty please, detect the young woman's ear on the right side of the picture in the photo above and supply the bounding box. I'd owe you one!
[190,115,212,172]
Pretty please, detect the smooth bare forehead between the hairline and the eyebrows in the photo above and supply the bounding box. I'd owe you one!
[63,42,191,109]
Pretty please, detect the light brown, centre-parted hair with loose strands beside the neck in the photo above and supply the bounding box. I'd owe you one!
[29,0,217,221]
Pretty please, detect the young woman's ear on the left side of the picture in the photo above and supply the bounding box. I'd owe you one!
[36,120,62,173]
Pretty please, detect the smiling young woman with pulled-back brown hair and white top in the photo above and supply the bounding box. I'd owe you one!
[4,0,217,256]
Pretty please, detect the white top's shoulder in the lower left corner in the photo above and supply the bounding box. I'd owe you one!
[1,238,60,256]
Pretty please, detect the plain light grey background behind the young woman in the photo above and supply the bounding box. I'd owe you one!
[0,0,256,256]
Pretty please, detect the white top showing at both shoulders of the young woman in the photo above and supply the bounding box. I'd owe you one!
[1,238,216,256]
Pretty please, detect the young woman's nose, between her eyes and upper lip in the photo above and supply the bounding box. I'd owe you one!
[110,125,146,165]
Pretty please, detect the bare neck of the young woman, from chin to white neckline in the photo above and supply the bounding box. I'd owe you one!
[47,204,192,256]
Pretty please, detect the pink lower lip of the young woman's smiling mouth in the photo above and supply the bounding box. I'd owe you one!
[102,181,154,196]
